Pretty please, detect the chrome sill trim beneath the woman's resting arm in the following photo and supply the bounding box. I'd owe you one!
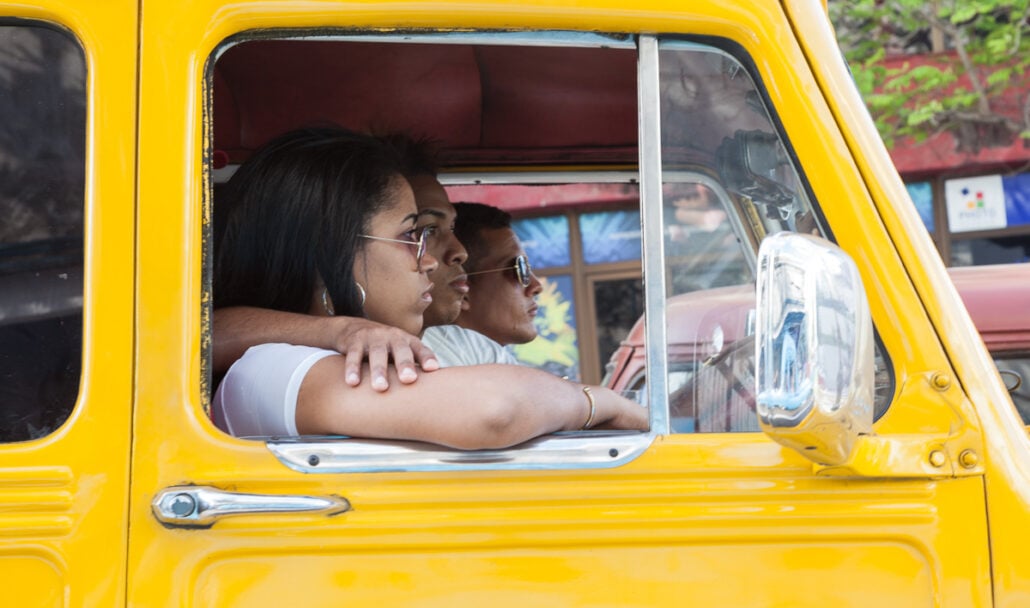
[266,431,655,473]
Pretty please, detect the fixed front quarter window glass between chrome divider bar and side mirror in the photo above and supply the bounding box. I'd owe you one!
[659,40,890,432]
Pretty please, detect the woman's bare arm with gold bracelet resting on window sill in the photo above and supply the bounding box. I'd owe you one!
[297,357,648,449]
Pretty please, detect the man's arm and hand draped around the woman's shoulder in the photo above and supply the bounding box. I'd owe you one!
[211,306,440,391]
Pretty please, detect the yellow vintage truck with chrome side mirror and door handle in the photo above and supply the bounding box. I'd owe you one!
[0,0,1030,608]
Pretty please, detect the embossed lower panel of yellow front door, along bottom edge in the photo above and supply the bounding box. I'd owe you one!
[187,541,934,608]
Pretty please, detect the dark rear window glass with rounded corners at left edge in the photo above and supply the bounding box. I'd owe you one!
[0,24,85,441]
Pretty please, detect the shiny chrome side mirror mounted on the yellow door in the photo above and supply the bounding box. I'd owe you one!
[755,232,873,466]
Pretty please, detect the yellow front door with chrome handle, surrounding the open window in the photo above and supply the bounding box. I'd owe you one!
[128,0,991,606]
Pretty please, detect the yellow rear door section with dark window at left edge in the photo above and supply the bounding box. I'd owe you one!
[0,0,137,607]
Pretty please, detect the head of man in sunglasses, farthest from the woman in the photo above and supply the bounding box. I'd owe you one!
[454,203,543,346]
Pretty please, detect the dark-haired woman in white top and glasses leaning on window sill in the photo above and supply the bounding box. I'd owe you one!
[213,129,648,449]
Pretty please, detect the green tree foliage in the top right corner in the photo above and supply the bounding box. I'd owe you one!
[829,0,1030,150]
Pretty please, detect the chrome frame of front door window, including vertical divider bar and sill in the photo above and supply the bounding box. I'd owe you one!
[202,30,894,473]
